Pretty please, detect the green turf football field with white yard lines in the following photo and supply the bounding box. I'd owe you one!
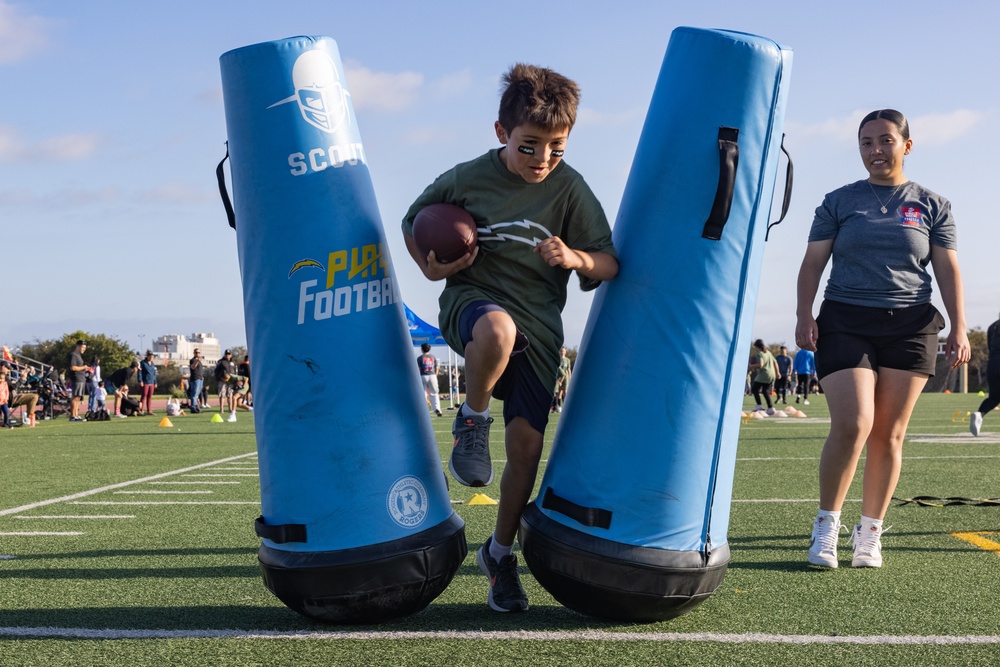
[0,394,1000,667]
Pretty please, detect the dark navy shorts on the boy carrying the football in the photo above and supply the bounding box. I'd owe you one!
[459,301,553,433]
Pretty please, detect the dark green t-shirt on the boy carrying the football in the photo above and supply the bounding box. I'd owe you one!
[402,149,617,387]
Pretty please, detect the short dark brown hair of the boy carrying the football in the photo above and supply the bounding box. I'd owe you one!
[497,63,580,134]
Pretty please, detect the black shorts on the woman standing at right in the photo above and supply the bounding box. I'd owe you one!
[816,301,944,379]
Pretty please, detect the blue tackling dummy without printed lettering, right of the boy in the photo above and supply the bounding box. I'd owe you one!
[520,28,791,621]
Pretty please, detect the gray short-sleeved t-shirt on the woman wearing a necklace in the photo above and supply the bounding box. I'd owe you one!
[809,180,956,308]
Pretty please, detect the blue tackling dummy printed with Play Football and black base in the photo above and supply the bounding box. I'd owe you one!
[216,37,467,623]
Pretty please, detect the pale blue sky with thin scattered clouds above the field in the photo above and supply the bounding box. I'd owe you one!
[0,0,1000,354]
